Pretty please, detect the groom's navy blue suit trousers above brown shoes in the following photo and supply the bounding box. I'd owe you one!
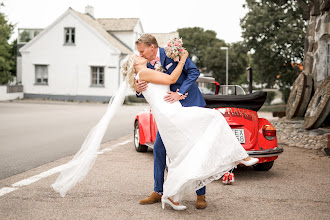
[153,132,206,195]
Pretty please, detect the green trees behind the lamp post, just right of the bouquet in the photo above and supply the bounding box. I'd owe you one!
[178,27,247,84]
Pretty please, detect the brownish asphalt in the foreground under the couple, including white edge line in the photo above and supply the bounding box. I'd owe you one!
[0,135,330,220]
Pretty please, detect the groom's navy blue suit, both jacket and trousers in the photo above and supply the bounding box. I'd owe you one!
[137,47,206,195]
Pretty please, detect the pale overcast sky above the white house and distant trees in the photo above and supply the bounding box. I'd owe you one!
[0,0,247,43]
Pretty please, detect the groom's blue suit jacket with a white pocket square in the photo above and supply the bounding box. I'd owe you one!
[138,47,206,107]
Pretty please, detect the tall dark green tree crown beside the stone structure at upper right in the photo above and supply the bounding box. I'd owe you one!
[241,0,305,88]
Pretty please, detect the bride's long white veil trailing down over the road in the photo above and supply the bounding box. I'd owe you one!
[51,80,128,197]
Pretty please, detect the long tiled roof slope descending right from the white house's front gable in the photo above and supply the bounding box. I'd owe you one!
[70,8,133,54]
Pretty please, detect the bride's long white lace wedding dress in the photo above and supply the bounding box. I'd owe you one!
[136,73,248,201]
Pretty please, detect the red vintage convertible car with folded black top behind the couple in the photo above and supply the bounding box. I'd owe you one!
[134,77,283,171]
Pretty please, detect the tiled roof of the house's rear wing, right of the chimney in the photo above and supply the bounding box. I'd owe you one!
[97,18,140,32]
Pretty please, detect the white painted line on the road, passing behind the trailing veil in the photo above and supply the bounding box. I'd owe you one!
[0,140,132,197]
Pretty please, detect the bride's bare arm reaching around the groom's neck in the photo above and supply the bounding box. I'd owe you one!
[139,50,188,85]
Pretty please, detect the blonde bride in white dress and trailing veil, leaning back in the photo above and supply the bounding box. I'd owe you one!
[52,51,258,210]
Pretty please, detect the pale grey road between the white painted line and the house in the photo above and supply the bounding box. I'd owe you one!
[0,100,149,180]
